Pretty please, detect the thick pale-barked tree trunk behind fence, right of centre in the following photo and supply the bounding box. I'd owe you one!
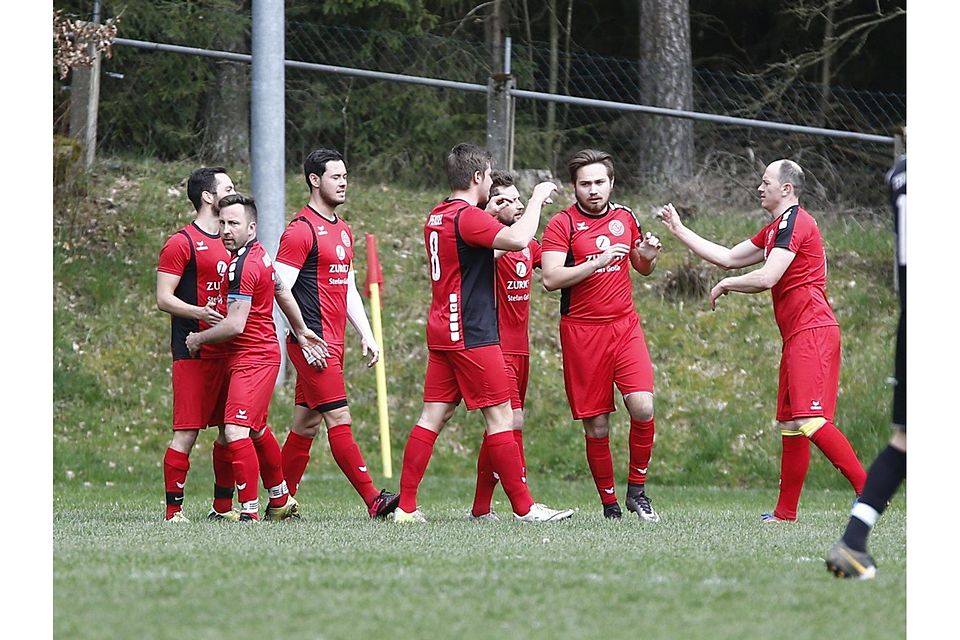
[636,0,694,183]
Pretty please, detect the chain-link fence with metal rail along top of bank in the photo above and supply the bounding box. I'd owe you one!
[54,16,906,210]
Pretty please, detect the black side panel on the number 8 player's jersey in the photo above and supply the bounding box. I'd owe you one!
[453,209,500,349]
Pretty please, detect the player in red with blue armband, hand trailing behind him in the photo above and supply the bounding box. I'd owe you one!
[186,193,325,521]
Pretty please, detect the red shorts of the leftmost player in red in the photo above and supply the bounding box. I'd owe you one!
[173,358,227,431]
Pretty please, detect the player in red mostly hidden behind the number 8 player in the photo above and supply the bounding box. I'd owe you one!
[471,170,556,521]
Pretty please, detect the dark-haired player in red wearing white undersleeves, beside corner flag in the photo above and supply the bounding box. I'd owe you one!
[274,149,399,518]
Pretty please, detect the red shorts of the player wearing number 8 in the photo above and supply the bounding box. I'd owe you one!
[423,344,510,411]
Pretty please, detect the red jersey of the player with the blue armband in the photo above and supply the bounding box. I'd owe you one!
[224,239,280,364]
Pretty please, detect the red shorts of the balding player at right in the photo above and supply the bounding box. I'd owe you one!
[777,326,840,422]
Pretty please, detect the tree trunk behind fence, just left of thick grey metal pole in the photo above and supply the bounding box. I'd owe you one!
[201,9,250,168]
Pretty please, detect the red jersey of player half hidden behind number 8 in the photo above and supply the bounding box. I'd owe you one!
[496,239,540,355]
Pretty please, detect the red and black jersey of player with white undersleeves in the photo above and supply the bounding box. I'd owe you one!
[277,205,353,344]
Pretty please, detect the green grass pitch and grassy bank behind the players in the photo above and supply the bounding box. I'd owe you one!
[52,160,906,640]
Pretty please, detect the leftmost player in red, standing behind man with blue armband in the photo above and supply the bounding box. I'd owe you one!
[157,167,240,522]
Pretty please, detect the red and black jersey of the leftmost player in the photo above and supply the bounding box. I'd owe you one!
[157,223,230,360]
